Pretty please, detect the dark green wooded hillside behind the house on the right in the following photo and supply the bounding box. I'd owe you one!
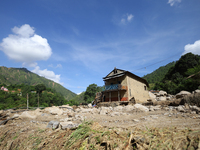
[144,53,200,94]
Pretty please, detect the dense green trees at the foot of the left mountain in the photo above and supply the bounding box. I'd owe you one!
[0,84,67,109]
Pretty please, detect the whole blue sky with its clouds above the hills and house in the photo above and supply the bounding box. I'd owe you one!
[0,0,200,93]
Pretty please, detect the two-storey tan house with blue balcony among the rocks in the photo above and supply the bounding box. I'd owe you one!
[102,68,150,103]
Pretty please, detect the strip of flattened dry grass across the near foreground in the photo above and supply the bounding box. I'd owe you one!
[0,121,200,150]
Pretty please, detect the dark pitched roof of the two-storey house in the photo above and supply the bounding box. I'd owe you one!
[103,68,149,87]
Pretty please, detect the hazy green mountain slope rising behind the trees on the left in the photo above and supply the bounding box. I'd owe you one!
[0,67,76,100]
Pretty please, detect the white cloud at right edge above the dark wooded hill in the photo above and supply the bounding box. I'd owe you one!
[183,40,200,55]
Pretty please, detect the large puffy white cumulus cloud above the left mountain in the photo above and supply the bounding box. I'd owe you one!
[0,24,52,66]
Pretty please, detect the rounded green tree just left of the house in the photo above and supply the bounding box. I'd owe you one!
[83,83,102,103]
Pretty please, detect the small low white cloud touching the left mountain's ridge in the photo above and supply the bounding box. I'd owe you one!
[32,66,63,84]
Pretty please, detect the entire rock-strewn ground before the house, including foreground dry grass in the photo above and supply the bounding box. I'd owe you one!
[0,104,200,150]
